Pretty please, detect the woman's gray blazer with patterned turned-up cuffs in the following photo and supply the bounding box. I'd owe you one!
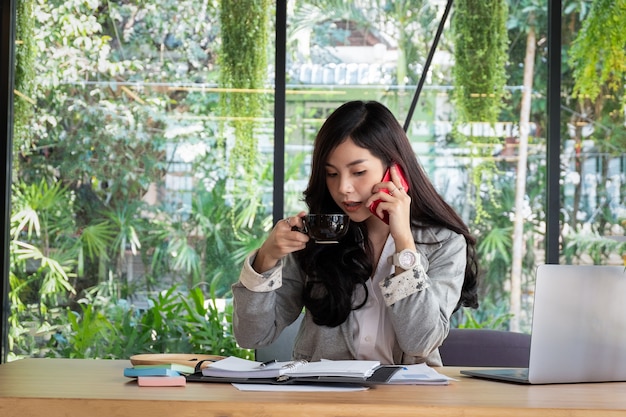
[232,227,467,366]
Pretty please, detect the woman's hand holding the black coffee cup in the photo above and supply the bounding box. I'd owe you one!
[252,211,309,273]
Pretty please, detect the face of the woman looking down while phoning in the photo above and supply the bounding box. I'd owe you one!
[326,138,386,222]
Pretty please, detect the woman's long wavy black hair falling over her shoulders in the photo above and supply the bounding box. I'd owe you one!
[296,101,478,326]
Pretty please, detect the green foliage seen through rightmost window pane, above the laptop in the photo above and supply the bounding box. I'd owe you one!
[564,0,626,263]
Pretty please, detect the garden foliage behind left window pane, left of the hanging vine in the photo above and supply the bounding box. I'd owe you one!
[9,0,269,357]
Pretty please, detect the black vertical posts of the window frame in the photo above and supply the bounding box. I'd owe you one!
[0,0,562,363]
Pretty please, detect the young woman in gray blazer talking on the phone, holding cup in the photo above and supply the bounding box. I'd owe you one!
[232,101,478,366]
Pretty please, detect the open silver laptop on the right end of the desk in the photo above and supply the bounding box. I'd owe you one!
[461,265,626,384]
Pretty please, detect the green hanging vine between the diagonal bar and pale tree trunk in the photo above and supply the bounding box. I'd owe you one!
[452,0,508,223]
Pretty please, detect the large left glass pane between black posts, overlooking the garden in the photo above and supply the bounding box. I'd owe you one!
[11,0,274,357]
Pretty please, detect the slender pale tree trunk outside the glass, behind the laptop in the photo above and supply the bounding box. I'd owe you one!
[510,21,536,331]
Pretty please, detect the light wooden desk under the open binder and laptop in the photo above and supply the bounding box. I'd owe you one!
[0,359,626,417]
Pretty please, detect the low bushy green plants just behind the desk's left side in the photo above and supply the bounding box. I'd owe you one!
[46,287,252,359]
